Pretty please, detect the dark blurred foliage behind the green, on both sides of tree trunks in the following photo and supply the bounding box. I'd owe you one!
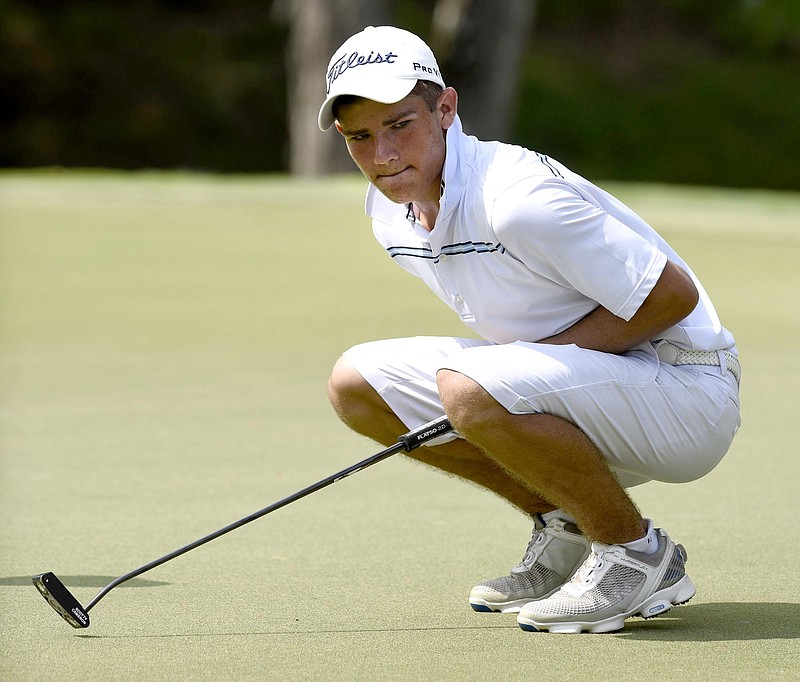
[0,0,800,189]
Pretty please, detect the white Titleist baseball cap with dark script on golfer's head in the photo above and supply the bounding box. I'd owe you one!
[318,26,445,130]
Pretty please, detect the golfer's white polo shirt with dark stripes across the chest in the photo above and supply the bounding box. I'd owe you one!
[366,118,734,350]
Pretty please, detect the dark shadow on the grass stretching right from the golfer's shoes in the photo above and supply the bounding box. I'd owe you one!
[616,602,800,642]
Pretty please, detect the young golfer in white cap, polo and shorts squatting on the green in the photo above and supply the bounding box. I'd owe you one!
[319,27,740,632]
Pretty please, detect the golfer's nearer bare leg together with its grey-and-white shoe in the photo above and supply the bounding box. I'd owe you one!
[437,370,695,633]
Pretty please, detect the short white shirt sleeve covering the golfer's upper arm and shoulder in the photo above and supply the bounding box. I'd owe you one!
[492,182,667,321]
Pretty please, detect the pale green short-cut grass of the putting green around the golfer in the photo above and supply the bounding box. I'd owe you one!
[0,172,800,680]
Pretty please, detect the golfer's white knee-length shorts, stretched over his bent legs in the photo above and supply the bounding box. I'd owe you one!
[344,337,740,487]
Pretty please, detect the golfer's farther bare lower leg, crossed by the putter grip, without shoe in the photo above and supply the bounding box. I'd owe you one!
[328,358,555,515]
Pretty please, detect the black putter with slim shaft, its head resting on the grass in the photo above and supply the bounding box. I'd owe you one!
[33,416,453,628]
